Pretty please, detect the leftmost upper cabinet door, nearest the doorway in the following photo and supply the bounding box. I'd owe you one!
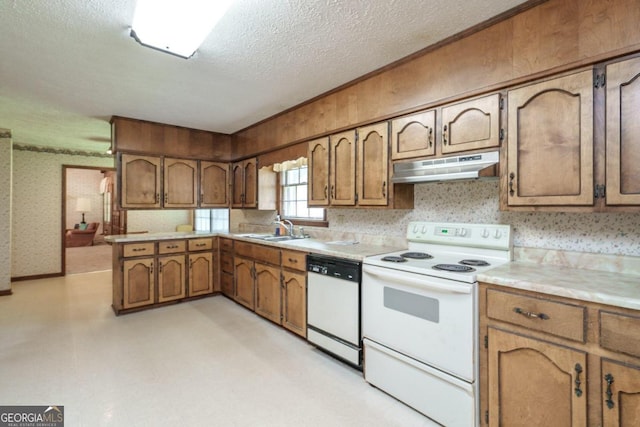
[121,154,162,208]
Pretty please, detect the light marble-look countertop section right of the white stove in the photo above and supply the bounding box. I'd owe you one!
[478,261,640,310]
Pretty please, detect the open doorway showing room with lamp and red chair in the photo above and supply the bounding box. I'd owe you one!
[61,165,126,275]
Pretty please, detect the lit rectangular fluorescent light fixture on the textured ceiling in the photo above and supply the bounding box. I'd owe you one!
[131,0,233,59]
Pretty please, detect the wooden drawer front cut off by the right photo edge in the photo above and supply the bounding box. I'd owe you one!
[599,311,640,357]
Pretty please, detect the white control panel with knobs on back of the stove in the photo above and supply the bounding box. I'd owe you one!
[407,221,512,250]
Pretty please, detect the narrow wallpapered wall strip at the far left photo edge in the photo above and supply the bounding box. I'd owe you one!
[0,135,12,291]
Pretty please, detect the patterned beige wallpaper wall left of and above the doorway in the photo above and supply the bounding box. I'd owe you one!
[11,150,114,277]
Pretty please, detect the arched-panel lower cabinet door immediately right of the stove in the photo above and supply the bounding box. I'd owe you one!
[488,327,587,427]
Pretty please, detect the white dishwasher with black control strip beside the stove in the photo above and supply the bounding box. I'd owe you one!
[307,255,362,369]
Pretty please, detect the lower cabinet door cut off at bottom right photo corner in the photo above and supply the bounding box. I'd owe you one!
[602,359,640,427]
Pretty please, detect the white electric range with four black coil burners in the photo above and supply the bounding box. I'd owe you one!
[362,222,513,427]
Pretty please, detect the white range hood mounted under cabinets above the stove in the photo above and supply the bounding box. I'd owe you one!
[391,151,500,183]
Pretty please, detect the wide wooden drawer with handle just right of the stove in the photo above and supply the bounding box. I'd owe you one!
[487,289,587,342]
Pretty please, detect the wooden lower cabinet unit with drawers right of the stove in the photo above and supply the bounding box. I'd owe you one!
[478,283,640,427]
